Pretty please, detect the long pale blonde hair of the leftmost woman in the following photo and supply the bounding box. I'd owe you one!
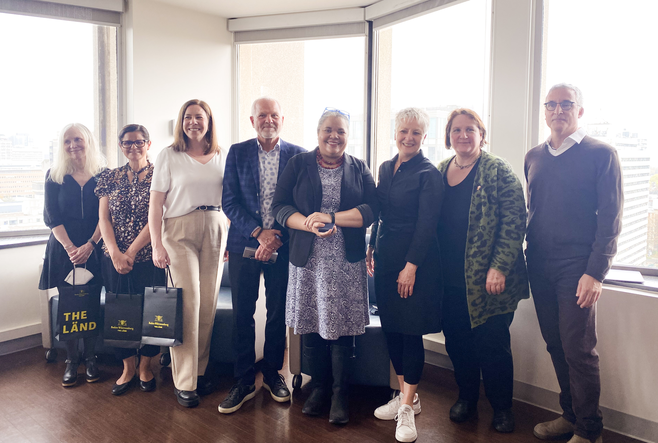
[50,123,106,185]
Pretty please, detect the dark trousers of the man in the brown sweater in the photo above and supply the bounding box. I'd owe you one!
[528,256,603,440]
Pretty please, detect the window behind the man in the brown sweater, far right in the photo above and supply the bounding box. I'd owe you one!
[540,0,658,267]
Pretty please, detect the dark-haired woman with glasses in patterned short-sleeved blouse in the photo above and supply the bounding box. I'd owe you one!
[96,124,164,395]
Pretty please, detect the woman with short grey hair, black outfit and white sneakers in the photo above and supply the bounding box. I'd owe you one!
[366,108,443,442]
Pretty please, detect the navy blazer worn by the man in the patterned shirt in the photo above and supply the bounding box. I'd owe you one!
[222,138,306,254]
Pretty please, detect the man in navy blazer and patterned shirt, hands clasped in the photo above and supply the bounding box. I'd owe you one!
[219,97,305,414]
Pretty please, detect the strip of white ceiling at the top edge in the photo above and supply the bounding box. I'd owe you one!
[149,0,378,18]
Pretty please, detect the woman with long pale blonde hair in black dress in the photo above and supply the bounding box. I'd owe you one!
[39,123,105,387]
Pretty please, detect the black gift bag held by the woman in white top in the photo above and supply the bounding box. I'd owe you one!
[142,266,183,347]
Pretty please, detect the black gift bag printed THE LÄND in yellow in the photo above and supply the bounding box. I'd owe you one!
[56,266,102,341]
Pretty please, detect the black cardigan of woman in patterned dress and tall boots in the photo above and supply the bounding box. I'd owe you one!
[272,148,379,267]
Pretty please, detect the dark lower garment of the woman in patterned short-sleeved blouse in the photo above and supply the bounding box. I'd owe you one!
[101,254,165,360]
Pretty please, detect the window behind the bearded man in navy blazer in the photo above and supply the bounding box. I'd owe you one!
[238,37,366,158]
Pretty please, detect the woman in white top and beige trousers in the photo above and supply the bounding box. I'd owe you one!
[149,100,226,407]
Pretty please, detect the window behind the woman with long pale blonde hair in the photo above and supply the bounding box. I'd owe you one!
[0,13,118,235]
